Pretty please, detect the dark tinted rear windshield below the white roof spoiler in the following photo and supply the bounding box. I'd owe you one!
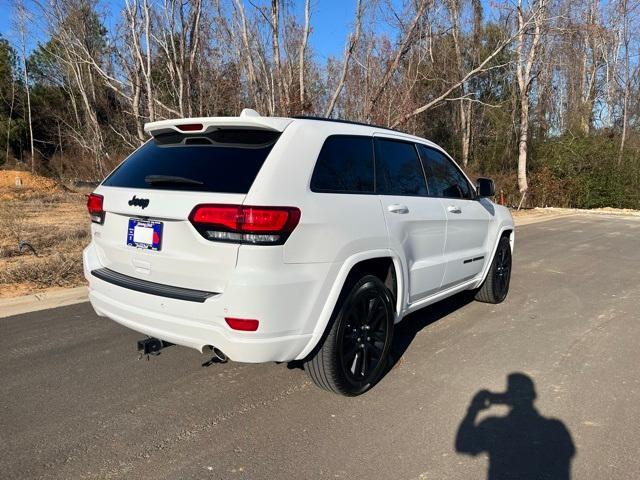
[102,129,280,193]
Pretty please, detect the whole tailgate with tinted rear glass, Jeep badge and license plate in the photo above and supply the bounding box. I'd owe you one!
[92,128,279,293]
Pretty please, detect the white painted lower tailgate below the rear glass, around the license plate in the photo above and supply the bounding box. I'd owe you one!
[93,187,245,292]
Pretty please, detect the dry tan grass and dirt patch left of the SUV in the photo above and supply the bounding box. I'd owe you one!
[0,172,90,298]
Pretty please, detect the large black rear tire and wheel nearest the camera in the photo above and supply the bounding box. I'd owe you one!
[304,275,394,396]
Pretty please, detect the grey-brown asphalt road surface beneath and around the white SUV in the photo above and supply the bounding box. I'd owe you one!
[0,216,640,479]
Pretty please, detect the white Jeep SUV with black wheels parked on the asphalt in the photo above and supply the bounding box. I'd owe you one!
[83,110,514,395]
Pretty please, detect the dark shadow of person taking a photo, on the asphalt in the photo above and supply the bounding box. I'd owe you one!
[455,373,576,480]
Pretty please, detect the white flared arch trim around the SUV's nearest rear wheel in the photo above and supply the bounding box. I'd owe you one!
[296,249,405,360]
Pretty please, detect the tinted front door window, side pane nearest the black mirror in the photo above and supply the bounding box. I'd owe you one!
[418,145,473,199]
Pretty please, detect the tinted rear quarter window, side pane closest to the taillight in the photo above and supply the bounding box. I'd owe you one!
[311,135,374,193]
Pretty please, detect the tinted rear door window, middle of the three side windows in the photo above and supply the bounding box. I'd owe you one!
[374,138,427,195]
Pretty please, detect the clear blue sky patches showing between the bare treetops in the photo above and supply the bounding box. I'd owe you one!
[0,0,370,60]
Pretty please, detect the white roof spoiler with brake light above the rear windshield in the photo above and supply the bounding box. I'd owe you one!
[144,108,293,136]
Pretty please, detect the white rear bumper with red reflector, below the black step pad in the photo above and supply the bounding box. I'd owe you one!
[83,244,329,363]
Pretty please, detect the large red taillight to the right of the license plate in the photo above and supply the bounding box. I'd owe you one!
[189,205,300,245]
